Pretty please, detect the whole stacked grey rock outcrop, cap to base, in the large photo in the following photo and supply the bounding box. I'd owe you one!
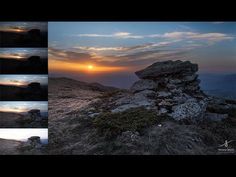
[109,60,207,121]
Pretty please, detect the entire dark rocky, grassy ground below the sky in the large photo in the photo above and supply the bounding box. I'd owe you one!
[49,60,236,155]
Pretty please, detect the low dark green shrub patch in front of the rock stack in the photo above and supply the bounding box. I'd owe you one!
[93,107,169,138]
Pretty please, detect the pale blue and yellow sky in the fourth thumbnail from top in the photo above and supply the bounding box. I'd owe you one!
[0,101,48,113]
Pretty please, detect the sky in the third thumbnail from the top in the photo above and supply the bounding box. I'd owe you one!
[0,75,48,86]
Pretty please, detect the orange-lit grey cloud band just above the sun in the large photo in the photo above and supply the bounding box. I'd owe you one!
[49,44,186,70]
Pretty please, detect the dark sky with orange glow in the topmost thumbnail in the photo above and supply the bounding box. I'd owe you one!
[0,22,47,33]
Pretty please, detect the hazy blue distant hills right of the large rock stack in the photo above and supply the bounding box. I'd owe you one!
[199,74,236,99]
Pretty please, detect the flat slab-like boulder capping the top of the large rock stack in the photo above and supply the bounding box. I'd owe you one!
[135,60,198,79]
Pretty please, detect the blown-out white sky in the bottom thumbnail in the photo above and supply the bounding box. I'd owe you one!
[0,128,48,141]
